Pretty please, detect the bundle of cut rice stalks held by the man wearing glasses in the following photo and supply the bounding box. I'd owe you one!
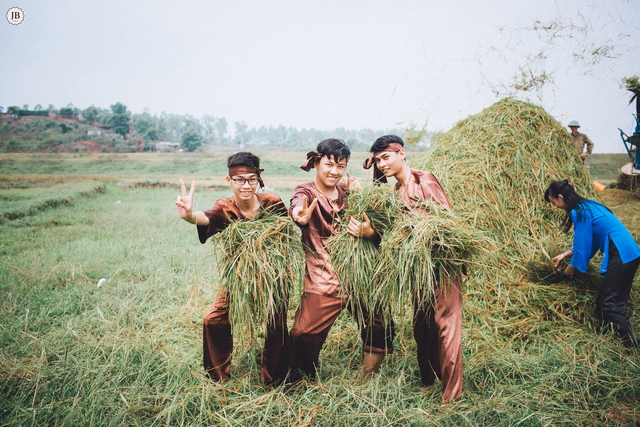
[213,213,305,336]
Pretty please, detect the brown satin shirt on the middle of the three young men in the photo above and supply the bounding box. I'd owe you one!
[289,182,347,297]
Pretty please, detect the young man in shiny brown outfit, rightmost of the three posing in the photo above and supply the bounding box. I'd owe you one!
[362,135,462,403]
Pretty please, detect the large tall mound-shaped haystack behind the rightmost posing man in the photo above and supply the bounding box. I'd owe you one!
[412,99,595,277]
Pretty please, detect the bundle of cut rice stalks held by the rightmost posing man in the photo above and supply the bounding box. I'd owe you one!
[373,201,492,317]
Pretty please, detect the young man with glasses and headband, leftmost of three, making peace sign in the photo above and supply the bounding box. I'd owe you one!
[176,152,288,385]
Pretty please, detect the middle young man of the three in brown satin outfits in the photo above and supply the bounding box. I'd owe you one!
[290,138,393,381]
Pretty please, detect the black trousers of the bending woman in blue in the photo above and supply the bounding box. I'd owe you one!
[596,241,640,347]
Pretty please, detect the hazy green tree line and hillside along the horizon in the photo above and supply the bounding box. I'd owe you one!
[0,102,424,152]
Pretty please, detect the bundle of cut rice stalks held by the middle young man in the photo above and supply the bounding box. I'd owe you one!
[327,185,404,318]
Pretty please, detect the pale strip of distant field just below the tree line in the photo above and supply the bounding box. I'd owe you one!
[0,151,629,183]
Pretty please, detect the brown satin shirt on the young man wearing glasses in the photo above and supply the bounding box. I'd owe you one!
[198,193,287,243]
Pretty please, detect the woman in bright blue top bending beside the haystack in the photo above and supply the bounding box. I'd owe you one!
[544,180,640,348]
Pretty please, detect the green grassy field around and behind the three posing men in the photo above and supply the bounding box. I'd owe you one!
[0,152,640,426]
